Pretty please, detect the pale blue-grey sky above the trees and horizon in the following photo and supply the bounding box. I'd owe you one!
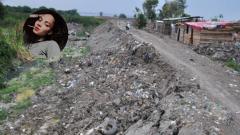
[3,0,240,20]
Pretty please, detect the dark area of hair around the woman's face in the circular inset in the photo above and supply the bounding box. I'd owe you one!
[23,9,68,50]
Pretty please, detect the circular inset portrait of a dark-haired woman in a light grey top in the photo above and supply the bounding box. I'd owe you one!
[23,9,68,61]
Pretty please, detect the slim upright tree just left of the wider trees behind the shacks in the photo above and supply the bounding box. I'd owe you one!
[143,0,158,20]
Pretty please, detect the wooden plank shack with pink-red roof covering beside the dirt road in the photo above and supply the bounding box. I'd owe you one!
[175,21,240,45]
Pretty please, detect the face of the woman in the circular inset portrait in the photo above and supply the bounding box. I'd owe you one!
[33,14,55,37]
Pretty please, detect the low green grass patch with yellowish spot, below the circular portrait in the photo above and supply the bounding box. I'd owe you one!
[0,66,55,121]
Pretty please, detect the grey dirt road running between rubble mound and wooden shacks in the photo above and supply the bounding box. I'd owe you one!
[115,19,240,133]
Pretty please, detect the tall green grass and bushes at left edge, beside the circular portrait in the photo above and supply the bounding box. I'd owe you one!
[0,8,32,89]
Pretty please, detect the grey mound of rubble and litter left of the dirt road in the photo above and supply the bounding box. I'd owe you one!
[1,22,232,135]
